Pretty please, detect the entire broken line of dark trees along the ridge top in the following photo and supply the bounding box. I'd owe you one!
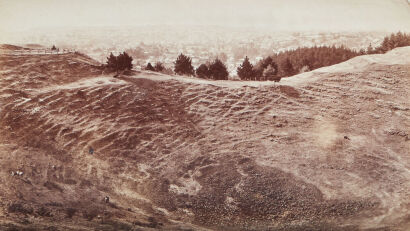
[107,32,410,82]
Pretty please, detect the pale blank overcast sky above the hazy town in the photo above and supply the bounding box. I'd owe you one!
[0,0,410,33]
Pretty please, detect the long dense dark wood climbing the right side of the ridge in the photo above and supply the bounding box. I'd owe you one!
[243,32,410,81]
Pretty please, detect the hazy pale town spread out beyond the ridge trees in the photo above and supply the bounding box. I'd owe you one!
[5,26,388,76]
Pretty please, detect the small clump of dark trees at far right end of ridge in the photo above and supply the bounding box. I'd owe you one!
[366,31,410,54]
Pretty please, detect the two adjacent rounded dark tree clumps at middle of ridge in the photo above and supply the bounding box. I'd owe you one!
[174,54,229,80]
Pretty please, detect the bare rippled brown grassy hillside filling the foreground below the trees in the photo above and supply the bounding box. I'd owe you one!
[0,47,410,230]
